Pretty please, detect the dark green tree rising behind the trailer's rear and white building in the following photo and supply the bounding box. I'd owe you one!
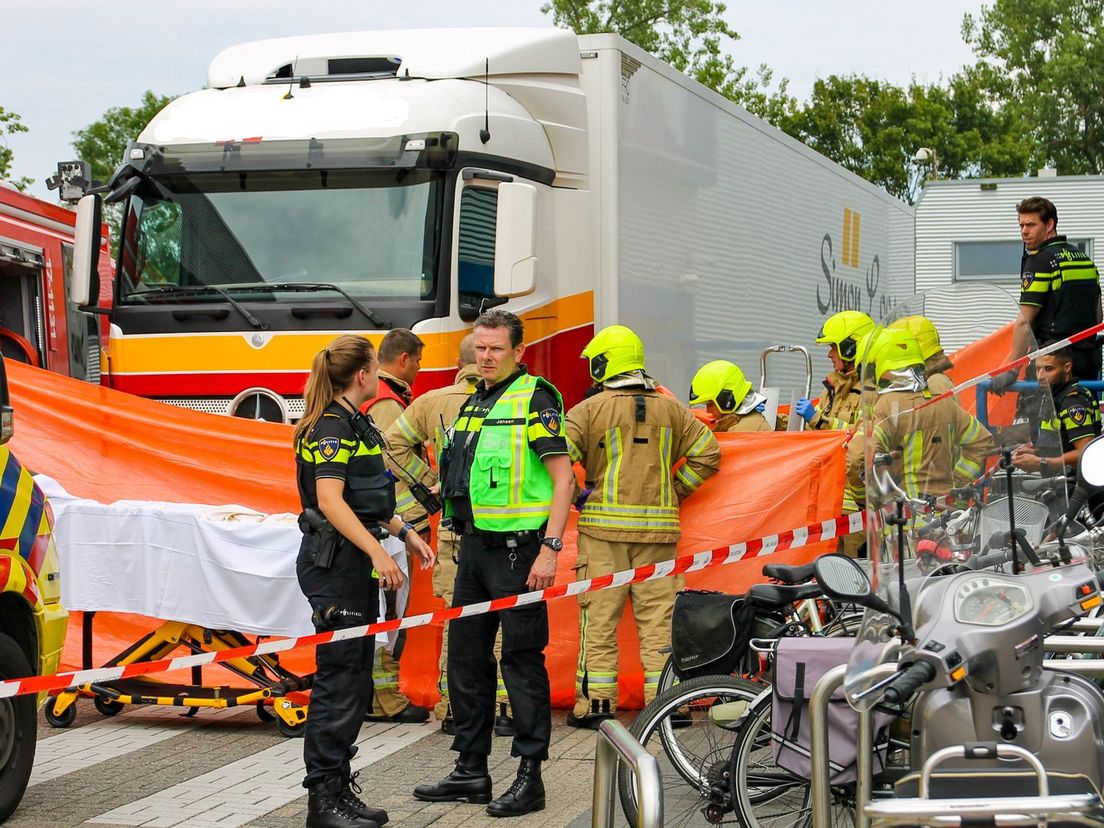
[779,70,1030,203]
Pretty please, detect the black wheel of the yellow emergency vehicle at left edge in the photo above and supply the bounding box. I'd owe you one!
[0,634,38,822]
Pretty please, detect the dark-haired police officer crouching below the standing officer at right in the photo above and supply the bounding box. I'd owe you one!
[1012,347,1101,477]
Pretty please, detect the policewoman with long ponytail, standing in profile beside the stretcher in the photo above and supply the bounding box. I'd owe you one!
[295,336,433,828]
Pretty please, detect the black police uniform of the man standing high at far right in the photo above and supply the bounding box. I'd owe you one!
[1020,236,1101,380]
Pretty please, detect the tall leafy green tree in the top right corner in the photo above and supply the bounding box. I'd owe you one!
[963,0,1104,174]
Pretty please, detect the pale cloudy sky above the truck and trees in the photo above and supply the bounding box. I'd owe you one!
[0,0,981,201]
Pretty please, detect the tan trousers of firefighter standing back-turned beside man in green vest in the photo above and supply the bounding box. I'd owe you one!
[575,532,679,716]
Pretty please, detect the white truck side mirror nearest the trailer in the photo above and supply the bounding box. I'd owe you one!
[495,181,537,297]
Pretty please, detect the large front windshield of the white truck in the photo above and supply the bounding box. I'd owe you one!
[119,169,444,304]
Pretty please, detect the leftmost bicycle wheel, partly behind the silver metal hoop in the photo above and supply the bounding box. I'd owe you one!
[617,676,763,826]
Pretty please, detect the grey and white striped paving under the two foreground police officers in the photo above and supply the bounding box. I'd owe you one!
[6,700,635,828]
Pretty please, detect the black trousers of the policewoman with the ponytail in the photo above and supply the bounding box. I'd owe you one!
[296,540,380,787]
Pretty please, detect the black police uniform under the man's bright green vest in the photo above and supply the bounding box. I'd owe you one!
[443,367,567,761]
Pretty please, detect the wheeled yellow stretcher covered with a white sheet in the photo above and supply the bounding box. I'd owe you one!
[38,476,406,736]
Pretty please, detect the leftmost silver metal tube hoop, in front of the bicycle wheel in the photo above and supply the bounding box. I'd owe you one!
[591,720,664,828]
